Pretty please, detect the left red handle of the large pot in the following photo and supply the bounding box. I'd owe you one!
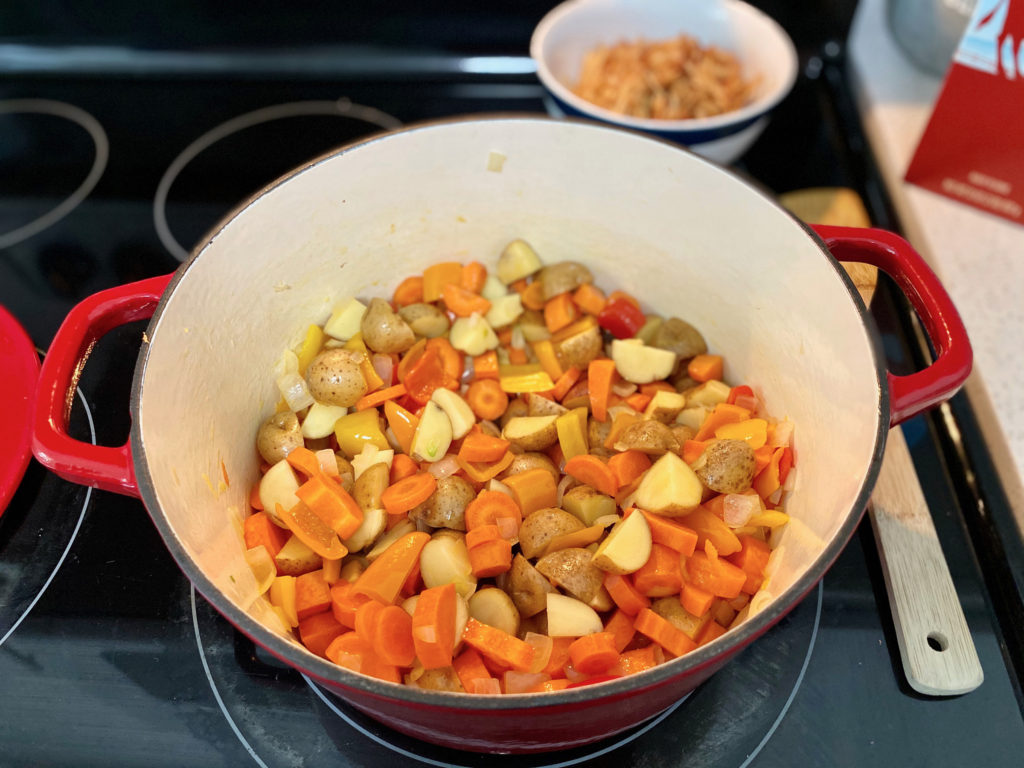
[32,274,173,497]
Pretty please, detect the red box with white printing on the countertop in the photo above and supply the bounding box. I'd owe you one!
[905,0,1024,223]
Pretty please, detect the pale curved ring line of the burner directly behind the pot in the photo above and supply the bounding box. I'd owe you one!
[153,98,401,261]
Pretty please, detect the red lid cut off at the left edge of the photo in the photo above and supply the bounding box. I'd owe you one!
[0,306,39,515]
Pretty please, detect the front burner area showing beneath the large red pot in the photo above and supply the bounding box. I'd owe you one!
[190,585,822,768]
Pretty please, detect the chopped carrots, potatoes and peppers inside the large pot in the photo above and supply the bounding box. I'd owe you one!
[244,240,794,693]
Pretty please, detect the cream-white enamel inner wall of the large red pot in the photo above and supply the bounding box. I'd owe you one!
[135,120,880,652]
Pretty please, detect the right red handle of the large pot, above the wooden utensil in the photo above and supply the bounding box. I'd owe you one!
[812,225,973,426]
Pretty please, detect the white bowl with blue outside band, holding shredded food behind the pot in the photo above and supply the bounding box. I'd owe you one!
[529,0,797,163]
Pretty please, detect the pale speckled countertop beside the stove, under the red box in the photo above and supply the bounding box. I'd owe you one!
[849,0,1024,535]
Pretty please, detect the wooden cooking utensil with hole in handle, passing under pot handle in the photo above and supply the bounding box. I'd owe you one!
[780,187,984,696]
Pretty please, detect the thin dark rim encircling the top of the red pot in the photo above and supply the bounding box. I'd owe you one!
[129,113,890,711]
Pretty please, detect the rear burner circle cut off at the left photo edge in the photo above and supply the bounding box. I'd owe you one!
[0,98,110,250]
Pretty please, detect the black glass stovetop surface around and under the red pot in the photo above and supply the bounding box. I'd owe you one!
[0,3,1024,768]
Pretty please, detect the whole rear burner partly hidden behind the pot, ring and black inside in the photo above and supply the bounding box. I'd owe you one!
[153,98,401,261]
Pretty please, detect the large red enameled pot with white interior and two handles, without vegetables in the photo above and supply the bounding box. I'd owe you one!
[34,118,971,752]
